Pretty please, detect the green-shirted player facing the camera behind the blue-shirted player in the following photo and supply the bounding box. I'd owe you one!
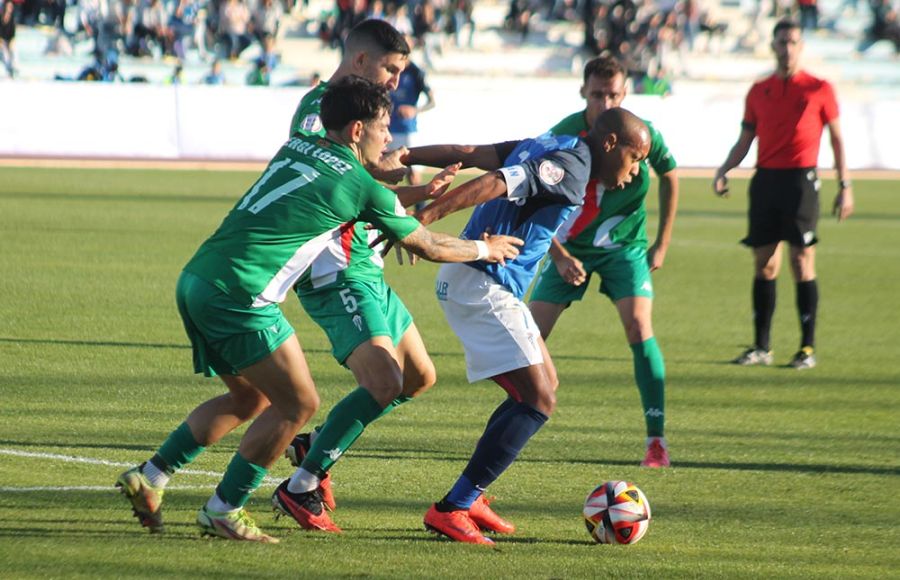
[529,57,678,467]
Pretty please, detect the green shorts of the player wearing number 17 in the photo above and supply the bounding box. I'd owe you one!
[175,272,294,377]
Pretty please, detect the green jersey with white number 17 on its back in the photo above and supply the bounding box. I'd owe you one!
[184,136,419,307]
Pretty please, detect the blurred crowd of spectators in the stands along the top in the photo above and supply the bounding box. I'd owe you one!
[0,0,900,85]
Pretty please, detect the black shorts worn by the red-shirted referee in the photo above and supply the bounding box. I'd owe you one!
[741,167,819,248]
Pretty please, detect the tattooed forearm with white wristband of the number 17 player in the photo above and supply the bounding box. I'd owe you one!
[400,226,525,265]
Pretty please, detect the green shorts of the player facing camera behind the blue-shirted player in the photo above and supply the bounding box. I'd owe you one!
[531,246,653,304]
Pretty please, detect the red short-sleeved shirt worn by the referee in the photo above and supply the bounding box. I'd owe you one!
[743,71,838,169]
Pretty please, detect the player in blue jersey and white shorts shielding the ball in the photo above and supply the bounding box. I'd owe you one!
[407,108,650,544]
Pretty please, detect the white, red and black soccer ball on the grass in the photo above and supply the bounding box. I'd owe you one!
[584,481,650,544]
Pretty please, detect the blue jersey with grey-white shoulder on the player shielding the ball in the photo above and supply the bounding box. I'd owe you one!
[461,133,591,299]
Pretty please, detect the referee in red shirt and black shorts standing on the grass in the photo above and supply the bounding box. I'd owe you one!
[713,20,853,370]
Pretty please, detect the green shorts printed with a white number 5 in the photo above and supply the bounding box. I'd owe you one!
[297,279,413,364]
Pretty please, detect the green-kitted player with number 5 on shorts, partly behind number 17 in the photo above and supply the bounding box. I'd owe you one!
[273,20,458,529]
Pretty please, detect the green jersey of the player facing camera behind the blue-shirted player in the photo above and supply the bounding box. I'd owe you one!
[550,111,676,253]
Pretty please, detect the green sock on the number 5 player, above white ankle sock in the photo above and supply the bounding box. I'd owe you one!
[301,387,386,478]
